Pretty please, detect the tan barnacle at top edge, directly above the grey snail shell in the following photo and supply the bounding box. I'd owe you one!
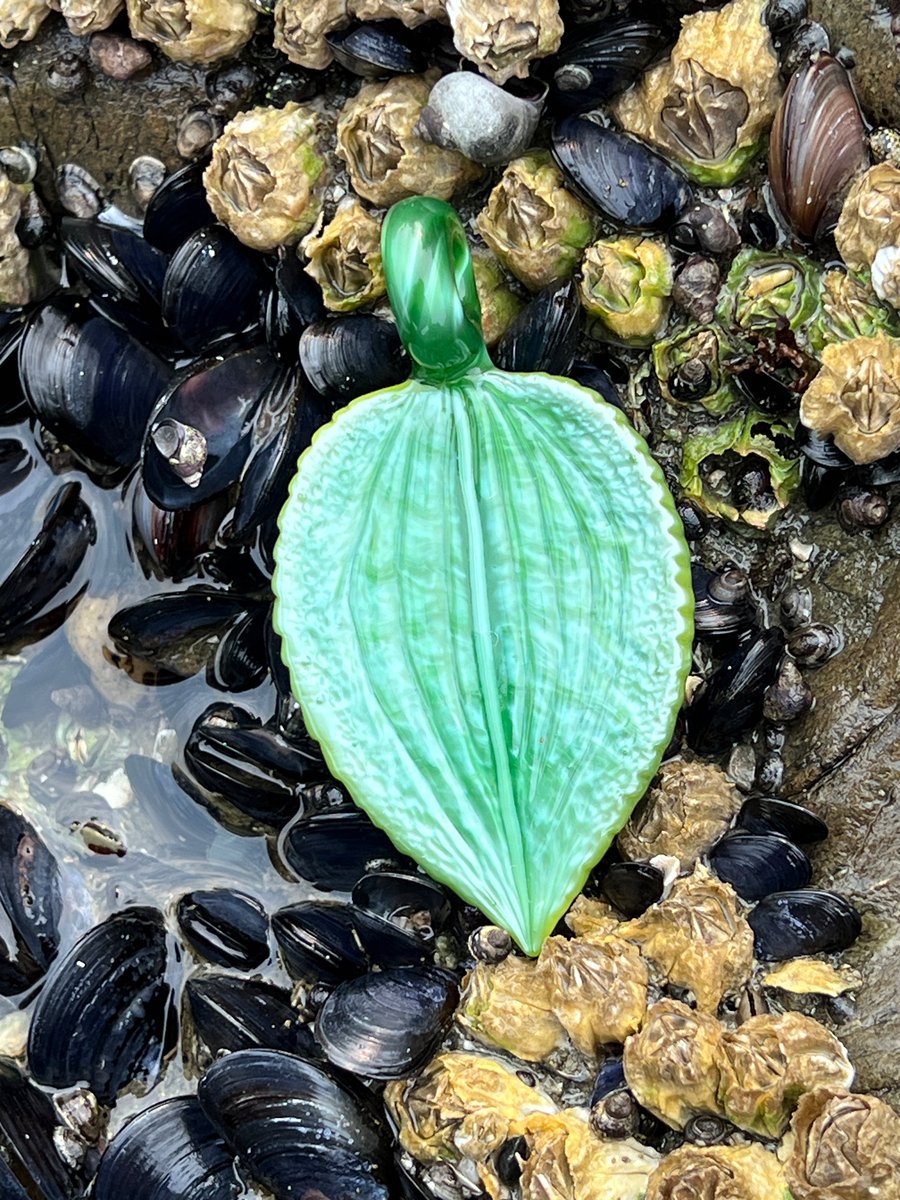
[446,0,563,83]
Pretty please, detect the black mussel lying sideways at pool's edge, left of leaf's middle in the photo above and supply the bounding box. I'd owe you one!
[109,587,257,684]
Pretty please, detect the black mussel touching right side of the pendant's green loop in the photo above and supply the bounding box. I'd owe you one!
[491,280,581,376]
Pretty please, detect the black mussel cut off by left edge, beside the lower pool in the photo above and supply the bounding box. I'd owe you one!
[0,804,62,990]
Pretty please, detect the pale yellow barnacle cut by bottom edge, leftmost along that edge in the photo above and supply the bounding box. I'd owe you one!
[521,1109,660,1200]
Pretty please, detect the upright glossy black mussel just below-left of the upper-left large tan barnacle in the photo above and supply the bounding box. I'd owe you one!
[162,226,265,352]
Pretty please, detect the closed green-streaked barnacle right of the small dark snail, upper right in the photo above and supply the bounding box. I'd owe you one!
[716,247,820,343]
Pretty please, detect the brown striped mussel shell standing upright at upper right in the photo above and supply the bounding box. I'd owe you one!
[769,54,869,241]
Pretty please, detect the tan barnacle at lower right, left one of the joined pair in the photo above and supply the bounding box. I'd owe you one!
[624,1000,724,1129]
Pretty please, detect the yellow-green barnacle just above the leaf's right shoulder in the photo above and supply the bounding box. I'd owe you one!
[578,235,672,346]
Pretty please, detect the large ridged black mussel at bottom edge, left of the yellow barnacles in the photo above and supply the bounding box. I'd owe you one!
[197,1050,390,1200]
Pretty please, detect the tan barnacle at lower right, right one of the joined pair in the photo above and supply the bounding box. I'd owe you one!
[716,1013,853,1138]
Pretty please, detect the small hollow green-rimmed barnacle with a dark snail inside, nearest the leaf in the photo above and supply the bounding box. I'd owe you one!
[653,325,738,416]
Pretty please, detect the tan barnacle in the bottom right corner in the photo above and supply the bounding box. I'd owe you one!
[785,1087,900,1200]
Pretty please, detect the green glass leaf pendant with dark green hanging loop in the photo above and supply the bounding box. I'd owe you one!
[274,197,692,954]
